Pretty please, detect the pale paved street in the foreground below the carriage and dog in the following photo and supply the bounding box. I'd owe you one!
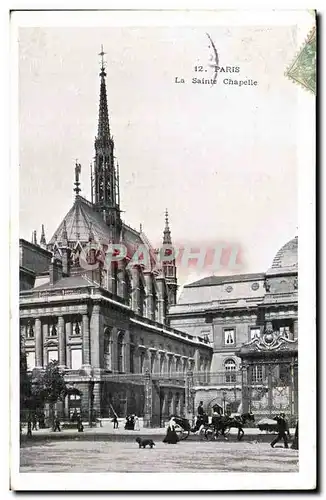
[21,438,298,473]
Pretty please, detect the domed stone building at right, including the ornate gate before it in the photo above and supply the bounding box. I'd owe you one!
[168,237,298,416]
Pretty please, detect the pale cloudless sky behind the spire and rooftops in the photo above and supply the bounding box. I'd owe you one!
[19,26,298,283]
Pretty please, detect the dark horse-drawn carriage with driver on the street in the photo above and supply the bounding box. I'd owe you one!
[173,413,255,441]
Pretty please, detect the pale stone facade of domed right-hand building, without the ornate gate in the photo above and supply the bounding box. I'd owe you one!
[168,238,298,411]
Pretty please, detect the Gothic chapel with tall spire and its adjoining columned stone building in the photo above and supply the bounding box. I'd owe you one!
[20,51,212,425]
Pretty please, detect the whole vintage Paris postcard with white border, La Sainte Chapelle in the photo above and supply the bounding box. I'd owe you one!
[10,10,317,491]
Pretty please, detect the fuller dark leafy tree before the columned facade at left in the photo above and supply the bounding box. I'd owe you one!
[32,361,68,425]
